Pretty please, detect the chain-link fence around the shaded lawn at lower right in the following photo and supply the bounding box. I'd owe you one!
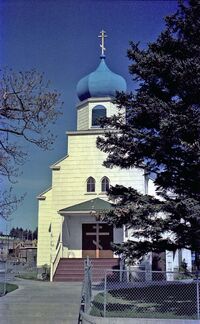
[80,266,200,320]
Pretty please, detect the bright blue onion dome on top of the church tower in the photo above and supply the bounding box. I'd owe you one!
[77,56,127,101]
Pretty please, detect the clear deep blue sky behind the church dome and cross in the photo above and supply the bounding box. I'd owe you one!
[0,0,177,232]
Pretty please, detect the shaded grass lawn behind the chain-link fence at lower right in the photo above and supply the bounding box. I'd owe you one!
[90,283,197,319]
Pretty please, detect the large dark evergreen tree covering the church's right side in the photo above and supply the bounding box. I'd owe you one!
[97,0,200,259]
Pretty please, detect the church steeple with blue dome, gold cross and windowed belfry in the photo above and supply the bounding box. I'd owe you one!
[77,30,126,130]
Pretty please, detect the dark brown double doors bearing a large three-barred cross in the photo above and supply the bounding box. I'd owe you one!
[82,223,113,258]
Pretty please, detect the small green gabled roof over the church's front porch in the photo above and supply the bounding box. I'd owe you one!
[58,198,113,214]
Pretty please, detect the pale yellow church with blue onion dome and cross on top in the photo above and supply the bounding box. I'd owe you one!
[37,31,191,280]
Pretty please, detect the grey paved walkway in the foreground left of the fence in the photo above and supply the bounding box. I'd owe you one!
[0,279,82,324]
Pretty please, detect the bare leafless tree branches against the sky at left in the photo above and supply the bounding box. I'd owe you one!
[0,69,62,219]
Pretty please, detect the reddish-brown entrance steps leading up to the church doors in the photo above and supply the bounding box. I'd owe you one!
[53,258,119,282]
